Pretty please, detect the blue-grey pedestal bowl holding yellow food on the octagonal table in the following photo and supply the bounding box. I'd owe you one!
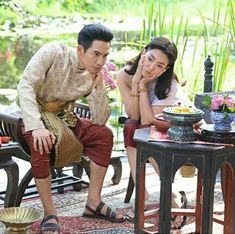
[163,107,204,142]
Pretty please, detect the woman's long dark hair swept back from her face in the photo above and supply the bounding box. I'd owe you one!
[125,37,178,100]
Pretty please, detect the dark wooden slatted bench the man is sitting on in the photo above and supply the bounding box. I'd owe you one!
[0,103,122,206]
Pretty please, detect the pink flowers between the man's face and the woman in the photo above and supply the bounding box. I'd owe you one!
[103,63,117,91]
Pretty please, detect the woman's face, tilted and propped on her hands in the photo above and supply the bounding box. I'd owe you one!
[142,49,169,77]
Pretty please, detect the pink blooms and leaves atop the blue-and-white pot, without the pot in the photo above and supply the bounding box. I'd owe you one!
[203,94,235,114]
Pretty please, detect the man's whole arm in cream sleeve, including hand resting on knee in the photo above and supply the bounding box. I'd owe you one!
[17,43,57,154]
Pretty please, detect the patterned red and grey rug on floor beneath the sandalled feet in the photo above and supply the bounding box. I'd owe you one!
[22,186,223,234]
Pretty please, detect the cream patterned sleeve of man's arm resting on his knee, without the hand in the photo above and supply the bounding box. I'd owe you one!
[17,43,57,131]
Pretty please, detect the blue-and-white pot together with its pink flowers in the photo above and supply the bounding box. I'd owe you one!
[203,94,235,131]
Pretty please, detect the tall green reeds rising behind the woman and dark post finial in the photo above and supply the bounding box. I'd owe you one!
[140,0,235,97]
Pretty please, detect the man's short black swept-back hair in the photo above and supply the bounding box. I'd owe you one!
[78,23,113,52]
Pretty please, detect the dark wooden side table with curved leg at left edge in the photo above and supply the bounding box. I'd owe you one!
[0,144,19,207]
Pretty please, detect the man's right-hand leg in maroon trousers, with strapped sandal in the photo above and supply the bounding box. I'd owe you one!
[74,119,124,222]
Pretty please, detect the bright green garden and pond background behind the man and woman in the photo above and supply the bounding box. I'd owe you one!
[0,0,235,148]
